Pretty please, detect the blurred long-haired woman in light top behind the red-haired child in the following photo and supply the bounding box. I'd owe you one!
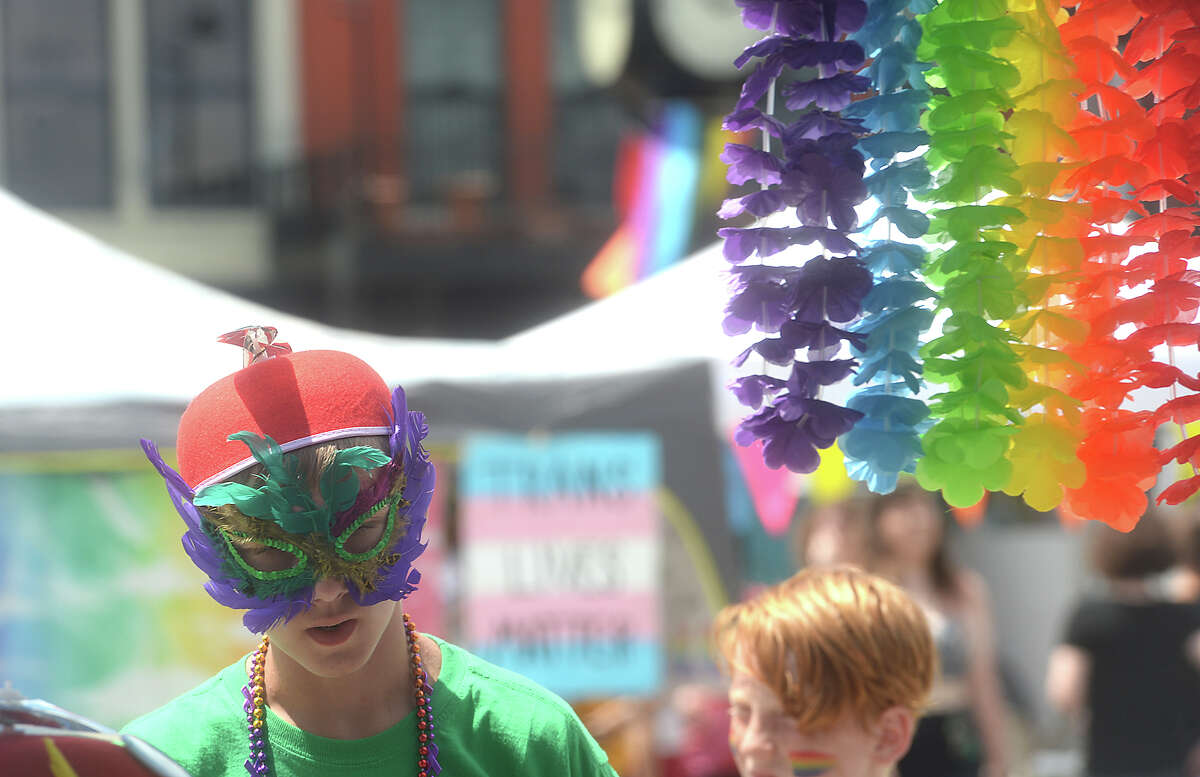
[868,481,1008,777]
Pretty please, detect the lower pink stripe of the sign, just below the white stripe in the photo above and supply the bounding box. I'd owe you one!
[463,591,662,644]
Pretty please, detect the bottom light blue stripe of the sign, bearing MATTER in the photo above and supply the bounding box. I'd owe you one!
[474,640,662,700]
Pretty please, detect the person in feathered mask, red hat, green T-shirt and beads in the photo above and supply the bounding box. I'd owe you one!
[125,327,614,777]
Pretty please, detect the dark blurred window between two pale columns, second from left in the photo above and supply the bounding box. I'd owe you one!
[142,0,256,206]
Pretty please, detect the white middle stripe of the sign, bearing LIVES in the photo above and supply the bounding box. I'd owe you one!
[462,537,660,597]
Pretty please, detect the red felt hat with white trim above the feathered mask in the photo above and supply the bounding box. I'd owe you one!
[176,350,392,489]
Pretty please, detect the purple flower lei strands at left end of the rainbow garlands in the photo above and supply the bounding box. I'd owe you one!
[718,0,872,472]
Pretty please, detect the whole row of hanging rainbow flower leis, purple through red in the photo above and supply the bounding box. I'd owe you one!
[719,0,1200,530]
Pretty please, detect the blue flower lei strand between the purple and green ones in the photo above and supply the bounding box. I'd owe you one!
[840,0,936,494]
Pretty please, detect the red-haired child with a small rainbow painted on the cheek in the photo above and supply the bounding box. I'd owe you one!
[714,566,936,777]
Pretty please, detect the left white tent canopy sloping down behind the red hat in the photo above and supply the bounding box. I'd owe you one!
[0,191,497,408]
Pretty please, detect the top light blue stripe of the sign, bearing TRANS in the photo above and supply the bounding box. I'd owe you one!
[458,432,662,498]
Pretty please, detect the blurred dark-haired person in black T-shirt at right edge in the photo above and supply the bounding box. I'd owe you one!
[1046,513,1200,777]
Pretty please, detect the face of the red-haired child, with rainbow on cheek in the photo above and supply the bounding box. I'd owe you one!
[730,671,878,777]
